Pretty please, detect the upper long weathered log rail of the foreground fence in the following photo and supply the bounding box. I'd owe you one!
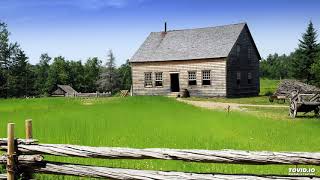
[2,144,320,165]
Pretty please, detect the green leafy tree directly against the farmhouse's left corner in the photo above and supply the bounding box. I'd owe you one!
[118,59,132,90]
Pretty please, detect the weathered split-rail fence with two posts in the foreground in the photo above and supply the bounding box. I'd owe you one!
[0,120,320,180]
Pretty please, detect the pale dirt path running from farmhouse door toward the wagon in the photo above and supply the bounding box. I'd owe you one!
[177,98,288,111]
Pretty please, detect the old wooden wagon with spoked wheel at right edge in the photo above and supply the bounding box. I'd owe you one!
[289,91,320,118]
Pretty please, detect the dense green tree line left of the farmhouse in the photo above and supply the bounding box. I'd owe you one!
[0,21,131,98]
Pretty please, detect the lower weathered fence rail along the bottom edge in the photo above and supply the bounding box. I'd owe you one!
[35,162,320,180]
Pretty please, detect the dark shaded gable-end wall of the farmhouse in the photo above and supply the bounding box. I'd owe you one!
[227,26,260,97]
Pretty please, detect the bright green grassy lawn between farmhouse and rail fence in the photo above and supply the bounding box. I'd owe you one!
[0,97,320,179]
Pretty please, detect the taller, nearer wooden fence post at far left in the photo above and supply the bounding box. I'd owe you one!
[7,123,15,180]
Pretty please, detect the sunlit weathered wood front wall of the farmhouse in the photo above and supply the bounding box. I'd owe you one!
[131,58,226,97]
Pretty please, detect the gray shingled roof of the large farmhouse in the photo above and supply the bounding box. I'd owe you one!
[130,23,246,62]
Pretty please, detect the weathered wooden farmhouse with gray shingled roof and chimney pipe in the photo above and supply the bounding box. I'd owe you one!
[130,23,261,97]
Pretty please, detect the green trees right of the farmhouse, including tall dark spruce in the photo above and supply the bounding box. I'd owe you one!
[260,21,320,86]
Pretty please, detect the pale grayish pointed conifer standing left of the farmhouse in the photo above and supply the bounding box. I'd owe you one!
[97,50,119,93]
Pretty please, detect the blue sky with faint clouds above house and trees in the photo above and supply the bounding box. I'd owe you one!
[0,0,320,65]
